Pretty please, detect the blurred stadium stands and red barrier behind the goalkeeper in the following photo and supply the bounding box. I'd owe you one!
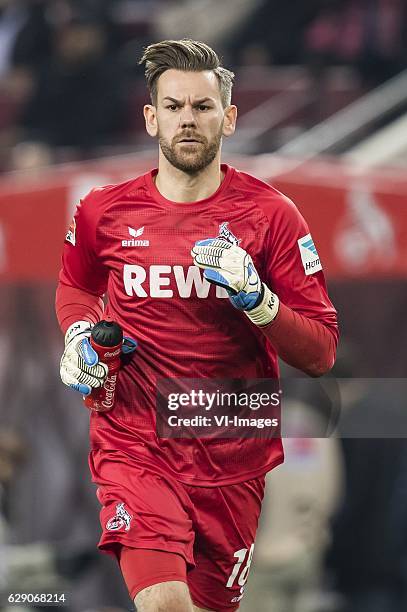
[0,0,407,612]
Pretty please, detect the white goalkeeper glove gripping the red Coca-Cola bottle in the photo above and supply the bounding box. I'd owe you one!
[60,321,108,395]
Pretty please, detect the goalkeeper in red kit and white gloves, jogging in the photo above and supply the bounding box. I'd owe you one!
[56,40,338,612]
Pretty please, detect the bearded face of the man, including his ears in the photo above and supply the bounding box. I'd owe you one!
[145,70,236,175]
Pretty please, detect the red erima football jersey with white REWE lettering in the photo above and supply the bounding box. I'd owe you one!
[60,165,338,486]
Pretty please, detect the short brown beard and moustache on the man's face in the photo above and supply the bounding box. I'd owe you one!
[158,125,223,175]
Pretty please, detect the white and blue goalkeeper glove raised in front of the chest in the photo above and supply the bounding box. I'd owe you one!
[191,238,279,327]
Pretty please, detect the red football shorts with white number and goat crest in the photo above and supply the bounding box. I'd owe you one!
[89,450,265,612]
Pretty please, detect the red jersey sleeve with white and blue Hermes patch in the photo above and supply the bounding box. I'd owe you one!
[264,196,338,339]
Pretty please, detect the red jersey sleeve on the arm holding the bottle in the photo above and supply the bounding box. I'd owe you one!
[59,190,109,297]
